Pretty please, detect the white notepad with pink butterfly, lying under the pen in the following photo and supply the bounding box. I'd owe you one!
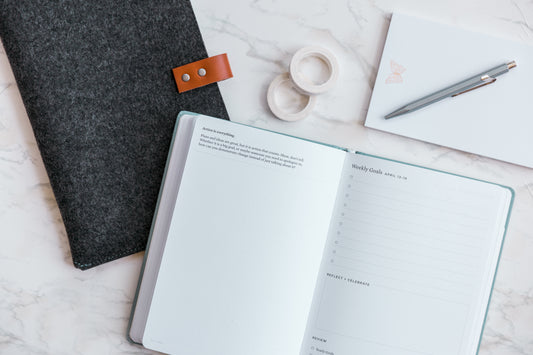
[365,14,533,167]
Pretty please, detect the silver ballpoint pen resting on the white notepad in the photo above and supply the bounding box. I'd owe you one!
[385,61,516,119]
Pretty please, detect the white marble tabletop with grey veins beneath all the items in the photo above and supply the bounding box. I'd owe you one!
[0,0,533,355]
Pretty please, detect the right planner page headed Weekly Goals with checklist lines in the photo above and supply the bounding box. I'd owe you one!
[301,154,513,355]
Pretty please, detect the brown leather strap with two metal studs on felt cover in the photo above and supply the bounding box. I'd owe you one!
[172,53,233,93]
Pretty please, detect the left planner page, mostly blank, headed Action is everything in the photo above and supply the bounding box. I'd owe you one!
[143,116,345,355]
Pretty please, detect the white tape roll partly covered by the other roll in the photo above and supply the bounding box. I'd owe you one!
[267,73,316,121]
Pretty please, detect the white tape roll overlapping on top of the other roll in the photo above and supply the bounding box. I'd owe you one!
[289,46,339,95]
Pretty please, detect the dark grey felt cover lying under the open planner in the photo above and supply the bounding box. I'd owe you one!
[0,0,227,269]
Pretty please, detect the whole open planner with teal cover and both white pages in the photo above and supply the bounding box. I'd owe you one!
[128,113,513,355]
